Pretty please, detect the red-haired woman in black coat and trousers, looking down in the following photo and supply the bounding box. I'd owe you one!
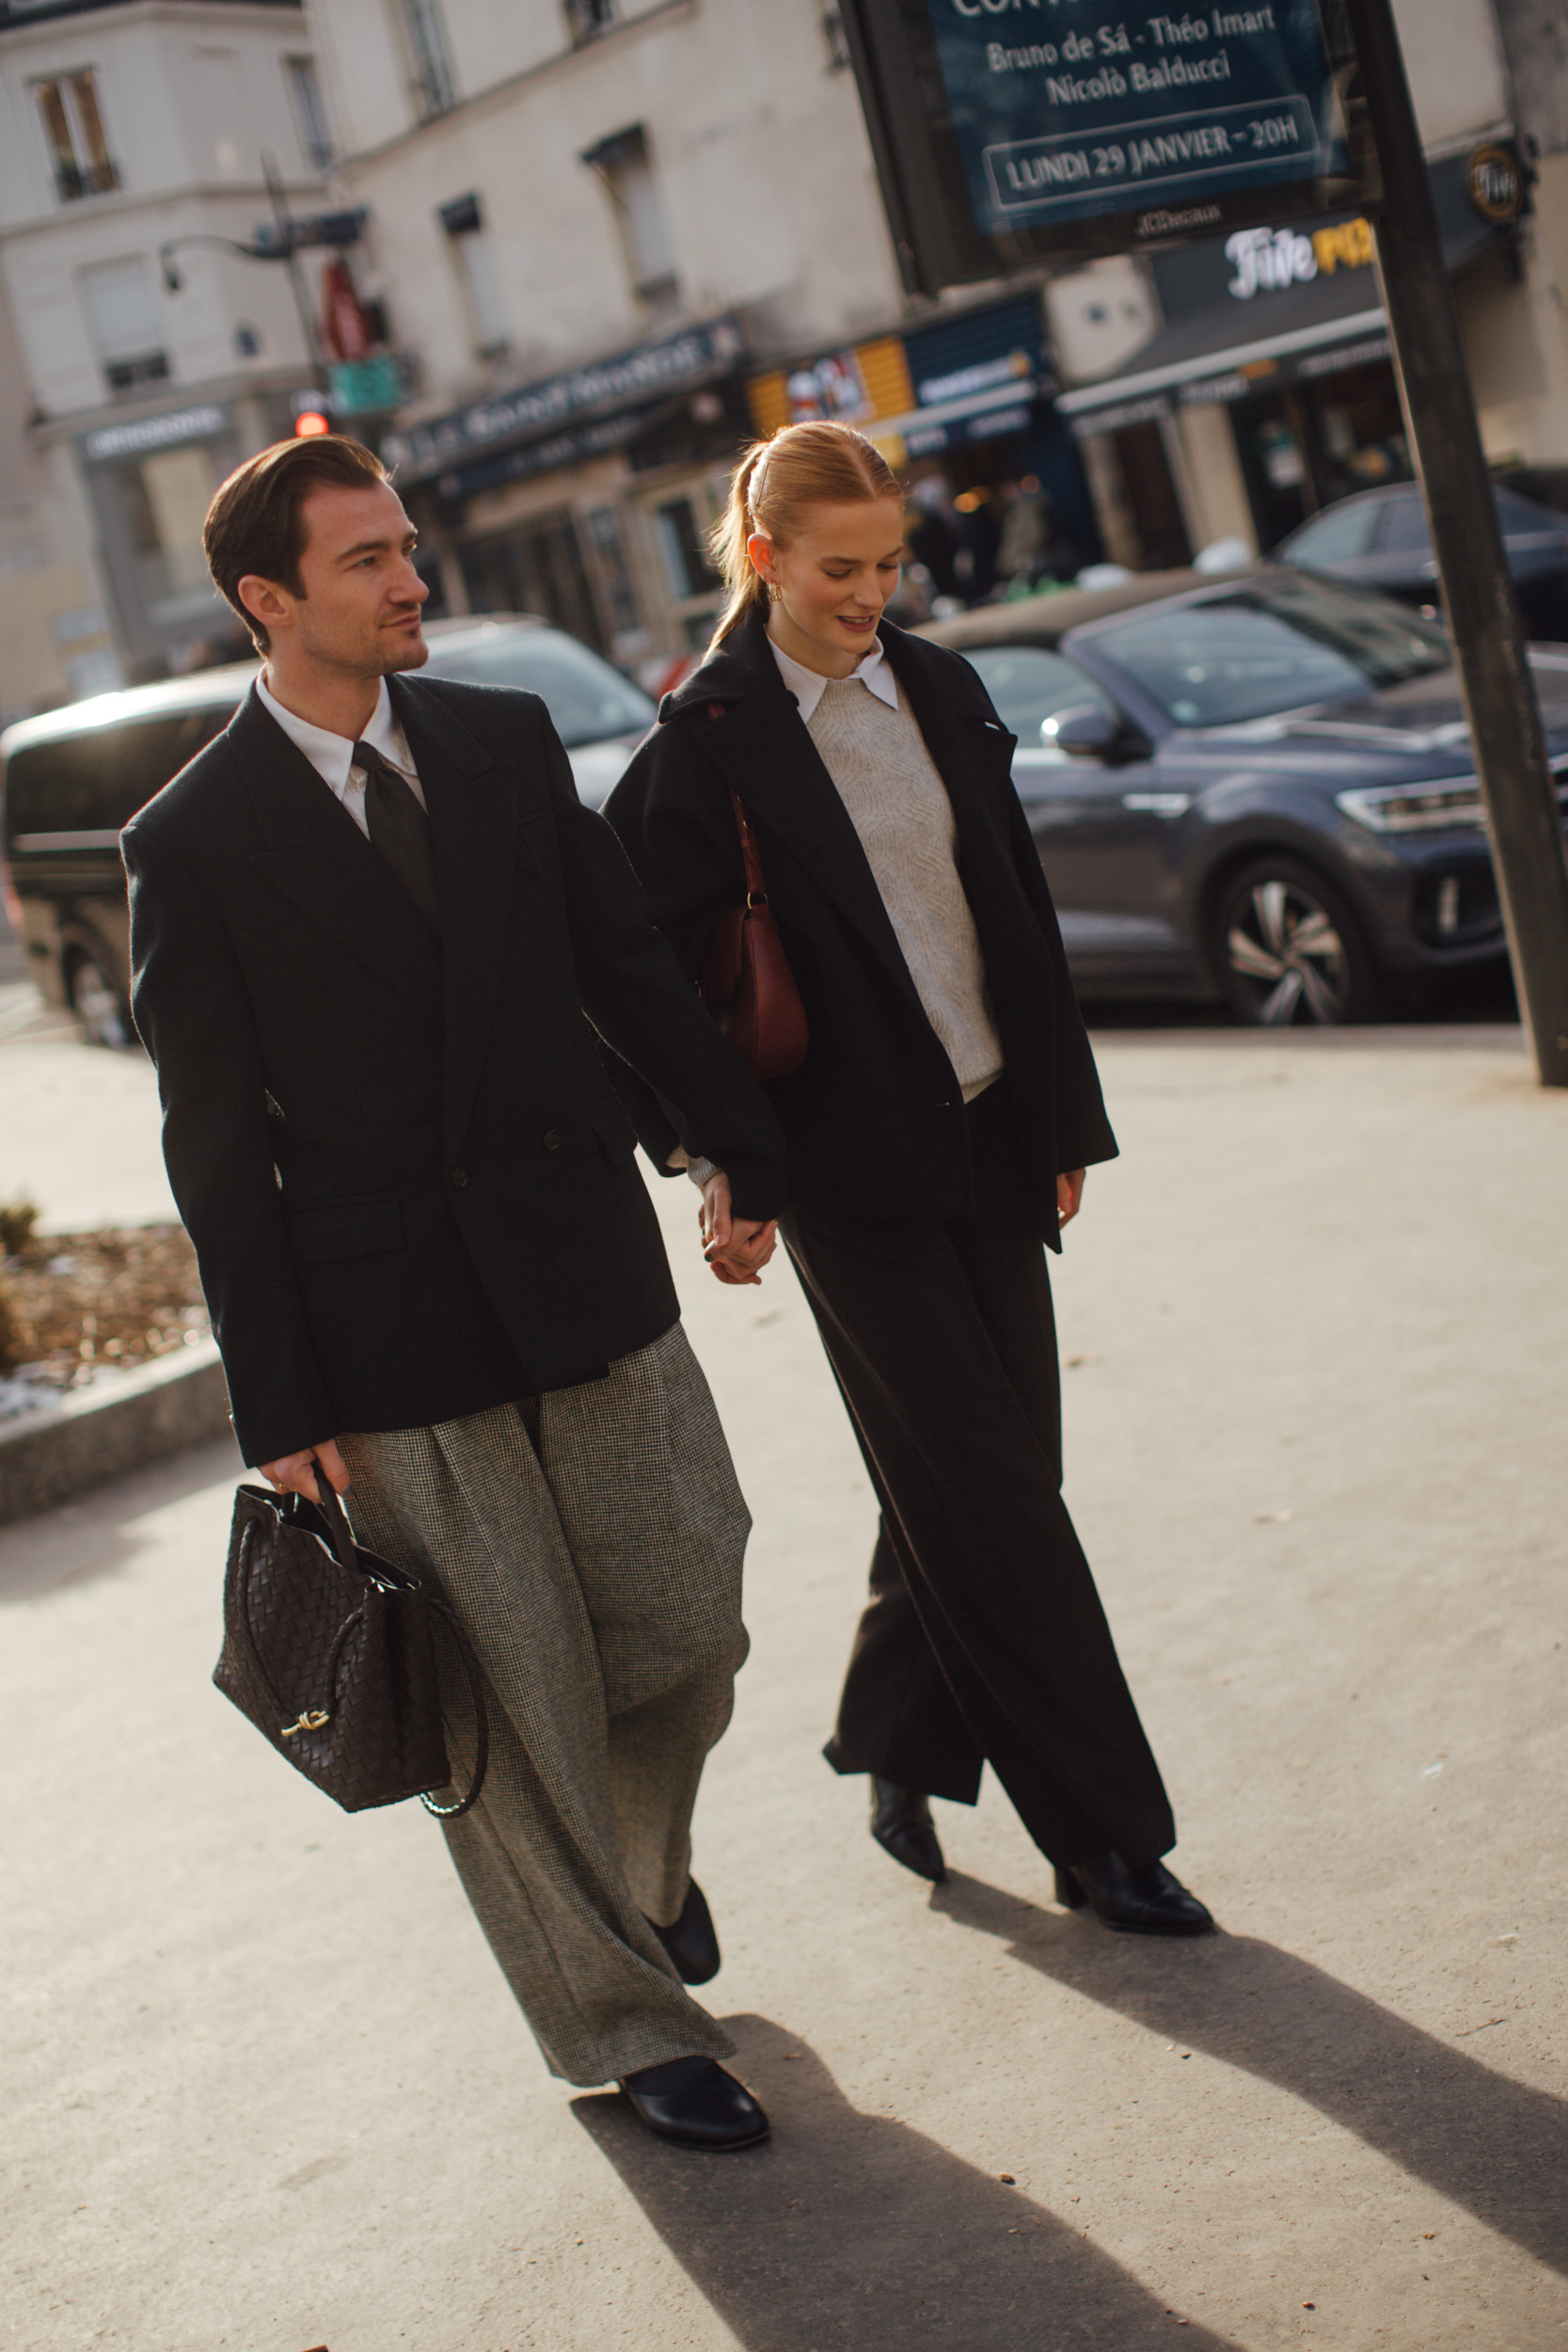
[607,423,1213,1936]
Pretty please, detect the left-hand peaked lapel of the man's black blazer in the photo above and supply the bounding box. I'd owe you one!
[228,690,442,1014]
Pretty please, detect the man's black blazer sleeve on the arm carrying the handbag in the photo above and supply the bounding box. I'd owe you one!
[122,826,339,1463]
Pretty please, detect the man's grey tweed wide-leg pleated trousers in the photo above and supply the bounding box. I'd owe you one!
[341,1325,750,2084]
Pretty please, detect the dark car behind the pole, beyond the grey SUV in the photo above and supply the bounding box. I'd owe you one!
[1275,483,1568,640]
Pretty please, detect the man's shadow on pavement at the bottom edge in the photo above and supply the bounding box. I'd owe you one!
[571,2016,1232,2352]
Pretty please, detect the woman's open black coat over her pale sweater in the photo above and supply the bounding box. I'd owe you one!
[604,612,1117,1249]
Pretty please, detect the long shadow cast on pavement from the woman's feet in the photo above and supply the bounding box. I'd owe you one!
[931,1875,1568,2270]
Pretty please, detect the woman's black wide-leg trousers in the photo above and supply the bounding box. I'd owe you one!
[783,1080,1176,1866]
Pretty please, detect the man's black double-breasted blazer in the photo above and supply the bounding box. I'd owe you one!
[122,677,785,1463]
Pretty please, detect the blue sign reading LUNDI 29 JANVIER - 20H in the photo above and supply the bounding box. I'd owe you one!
[847,0,1370,292]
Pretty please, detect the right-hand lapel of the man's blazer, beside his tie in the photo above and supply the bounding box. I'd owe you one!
[390,677,517,1157]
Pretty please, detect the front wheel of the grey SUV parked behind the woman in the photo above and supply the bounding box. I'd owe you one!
[1209,851,1387,1028]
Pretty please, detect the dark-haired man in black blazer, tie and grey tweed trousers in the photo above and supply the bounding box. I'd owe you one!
[124,437,783,2148]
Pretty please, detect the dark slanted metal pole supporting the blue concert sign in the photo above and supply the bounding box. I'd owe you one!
[1345,0,1568,1087]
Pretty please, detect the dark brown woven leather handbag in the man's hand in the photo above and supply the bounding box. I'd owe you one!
[212,1486,451,1814]
